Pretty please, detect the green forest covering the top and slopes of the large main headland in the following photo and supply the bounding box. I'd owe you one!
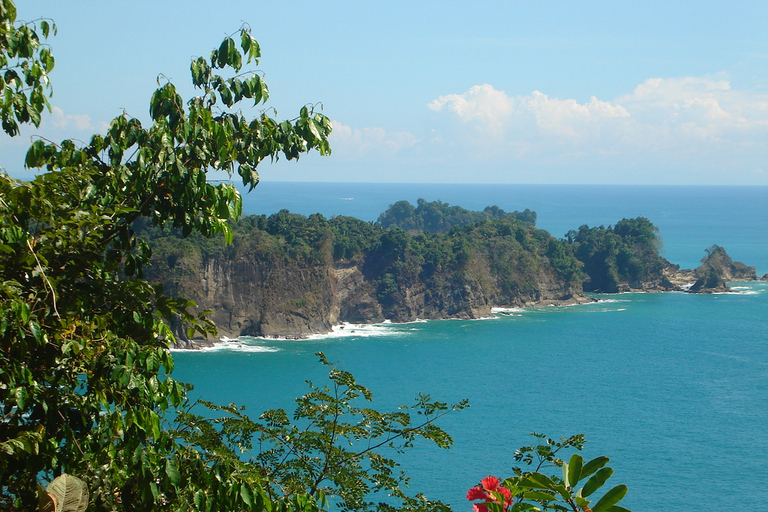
[141,203,581,319]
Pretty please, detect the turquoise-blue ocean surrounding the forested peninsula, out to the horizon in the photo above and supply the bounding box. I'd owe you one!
[174,183,768,512]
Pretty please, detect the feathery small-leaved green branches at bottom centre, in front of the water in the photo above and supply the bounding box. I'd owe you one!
[178,352,468,511]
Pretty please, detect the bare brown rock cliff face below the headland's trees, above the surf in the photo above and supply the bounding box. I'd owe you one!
[152,237,588,344]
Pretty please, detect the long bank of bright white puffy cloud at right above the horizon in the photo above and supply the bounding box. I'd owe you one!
[428,77,768,155]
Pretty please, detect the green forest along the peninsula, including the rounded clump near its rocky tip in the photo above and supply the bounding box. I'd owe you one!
[148,201,668,318]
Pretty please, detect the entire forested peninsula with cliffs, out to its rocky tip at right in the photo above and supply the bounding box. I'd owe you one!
[140,199,756,347]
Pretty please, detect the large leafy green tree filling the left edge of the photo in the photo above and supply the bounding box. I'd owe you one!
[0,0,331,510]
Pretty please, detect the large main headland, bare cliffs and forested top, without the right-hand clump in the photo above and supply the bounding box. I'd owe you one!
[146,206,590,338]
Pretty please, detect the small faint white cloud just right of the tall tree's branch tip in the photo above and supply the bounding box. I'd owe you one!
[330,121,419,156]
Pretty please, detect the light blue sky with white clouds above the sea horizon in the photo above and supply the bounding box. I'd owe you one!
[0,0,768,185]
